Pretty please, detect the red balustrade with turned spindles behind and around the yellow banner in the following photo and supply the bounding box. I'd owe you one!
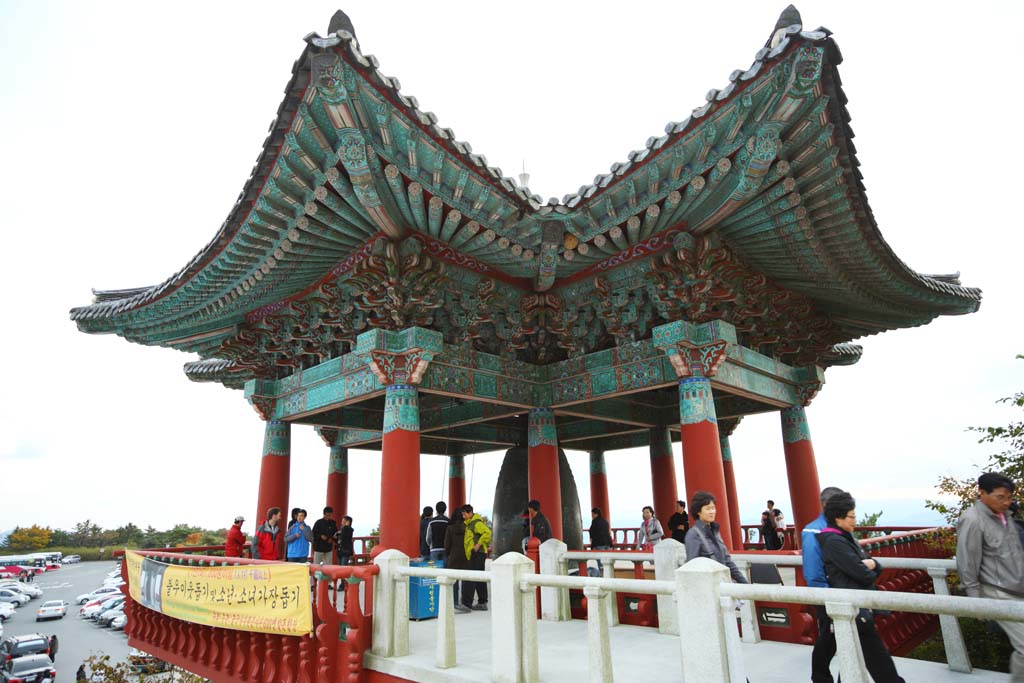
[121,549,379,683]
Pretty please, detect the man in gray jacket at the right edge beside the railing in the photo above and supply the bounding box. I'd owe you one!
[956,472,1024,683]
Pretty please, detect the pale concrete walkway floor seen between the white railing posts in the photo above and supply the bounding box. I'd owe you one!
[366,612,1010,683]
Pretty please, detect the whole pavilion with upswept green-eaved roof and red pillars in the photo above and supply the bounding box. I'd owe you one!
[71,6,981,555]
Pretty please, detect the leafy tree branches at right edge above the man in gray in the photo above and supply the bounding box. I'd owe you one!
[925,355,1024,524]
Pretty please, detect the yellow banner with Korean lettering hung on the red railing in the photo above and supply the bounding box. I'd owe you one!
[125,550,313,636]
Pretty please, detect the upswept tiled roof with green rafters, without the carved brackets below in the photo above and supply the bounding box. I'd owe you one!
[71,9,981,376]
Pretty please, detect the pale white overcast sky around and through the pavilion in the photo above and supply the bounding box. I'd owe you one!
[0,0,1024,533]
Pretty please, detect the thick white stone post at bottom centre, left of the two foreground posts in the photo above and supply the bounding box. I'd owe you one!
[490,553,537,683]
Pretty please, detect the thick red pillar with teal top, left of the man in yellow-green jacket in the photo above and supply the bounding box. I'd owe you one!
[380,384,420,557]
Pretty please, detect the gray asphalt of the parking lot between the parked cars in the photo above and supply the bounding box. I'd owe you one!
[3,561,128,683]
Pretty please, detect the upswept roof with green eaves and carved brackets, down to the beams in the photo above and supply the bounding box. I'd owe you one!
[72,5,981,386]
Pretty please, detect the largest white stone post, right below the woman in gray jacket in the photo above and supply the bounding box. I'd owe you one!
[675,557,733,683]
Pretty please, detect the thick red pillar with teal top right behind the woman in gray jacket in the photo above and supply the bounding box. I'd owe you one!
[679,377,736,549]
